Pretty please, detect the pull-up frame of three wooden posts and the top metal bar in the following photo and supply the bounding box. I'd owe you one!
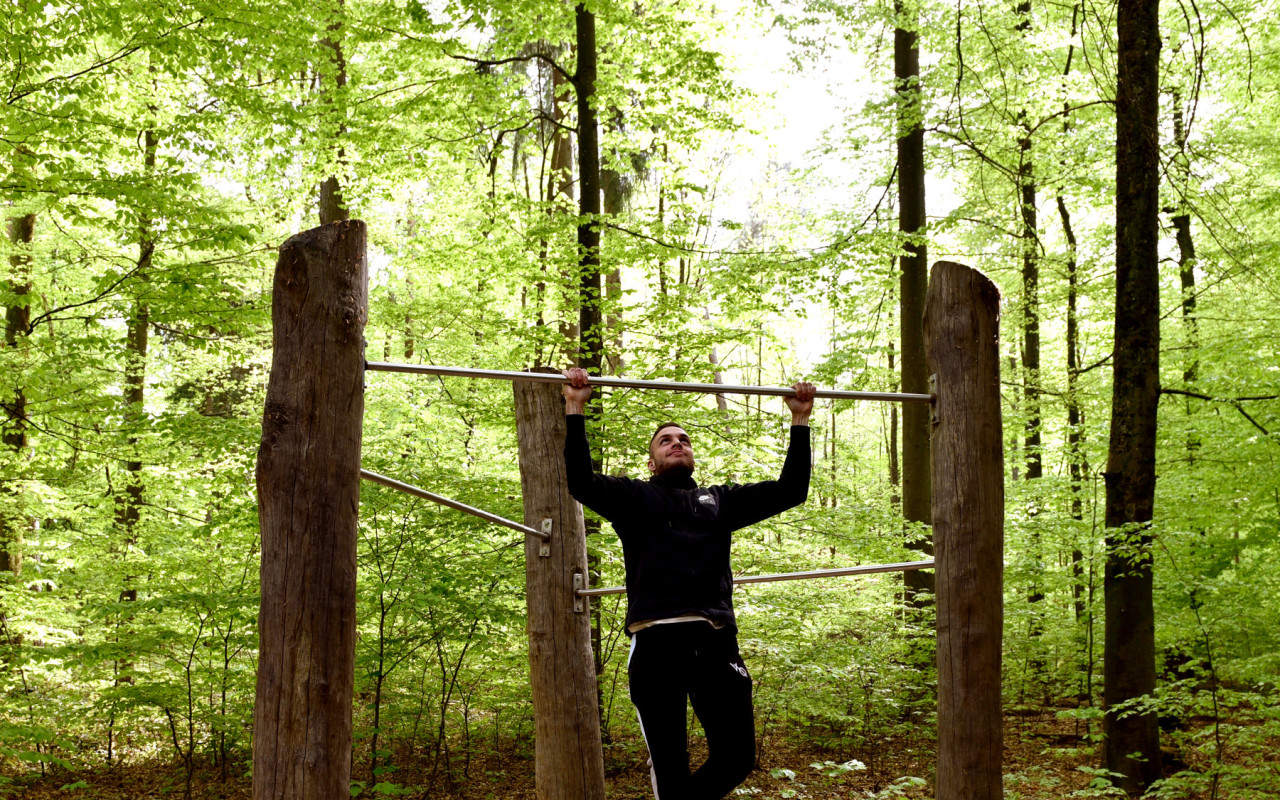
[253,220,1005,800]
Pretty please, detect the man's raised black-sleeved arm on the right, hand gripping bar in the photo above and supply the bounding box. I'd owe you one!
[721,381,814,530]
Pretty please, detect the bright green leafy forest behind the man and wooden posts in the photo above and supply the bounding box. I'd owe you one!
[0,0,1280,797]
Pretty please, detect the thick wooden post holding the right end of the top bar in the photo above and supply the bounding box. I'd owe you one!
[924,261,1005,800]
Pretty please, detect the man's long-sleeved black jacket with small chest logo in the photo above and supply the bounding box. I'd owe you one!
[564,415,810,628]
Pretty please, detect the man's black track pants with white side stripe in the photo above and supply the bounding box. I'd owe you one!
[627,622,755,800]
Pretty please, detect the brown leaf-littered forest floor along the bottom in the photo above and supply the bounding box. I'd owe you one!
[10,710,1198,800]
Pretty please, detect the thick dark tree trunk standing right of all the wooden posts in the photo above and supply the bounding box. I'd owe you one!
[1103,0,1161,797]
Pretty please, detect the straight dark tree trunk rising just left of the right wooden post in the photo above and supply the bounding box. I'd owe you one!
[893,0,933,605]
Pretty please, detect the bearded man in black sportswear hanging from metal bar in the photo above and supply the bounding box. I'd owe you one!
[564,367,814,800]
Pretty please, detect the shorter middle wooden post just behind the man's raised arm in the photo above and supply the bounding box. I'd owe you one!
[512,380,604,800]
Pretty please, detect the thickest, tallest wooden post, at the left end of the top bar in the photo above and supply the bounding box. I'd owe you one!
[253,221,367,800]
